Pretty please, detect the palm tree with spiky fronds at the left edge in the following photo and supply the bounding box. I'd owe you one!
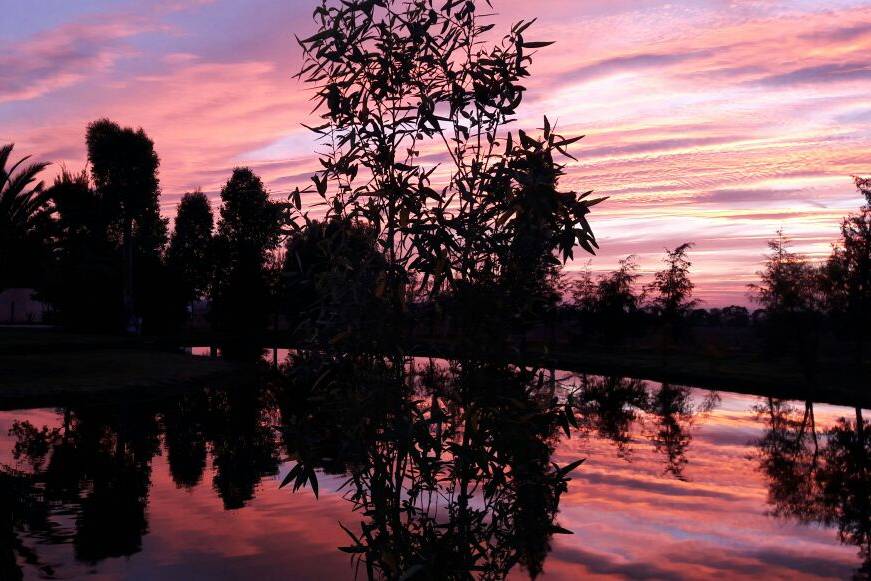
[0,143,54,289]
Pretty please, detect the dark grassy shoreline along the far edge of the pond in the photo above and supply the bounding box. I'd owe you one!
[0,328,871,409]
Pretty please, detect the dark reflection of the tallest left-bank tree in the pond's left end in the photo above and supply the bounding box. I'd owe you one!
[4,406,159,563]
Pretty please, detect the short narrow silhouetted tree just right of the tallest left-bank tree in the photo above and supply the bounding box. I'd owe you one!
[166,192,215,326]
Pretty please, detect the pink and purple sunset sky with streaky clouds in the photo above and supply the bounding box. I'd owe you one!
[0,0,871,306]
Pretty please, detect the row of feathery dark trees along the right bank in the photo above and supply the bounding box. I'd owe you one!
[560,178,871,363]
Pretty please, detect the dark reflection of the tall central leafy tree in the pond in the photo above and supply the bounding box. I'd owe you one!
[283,358,579,579]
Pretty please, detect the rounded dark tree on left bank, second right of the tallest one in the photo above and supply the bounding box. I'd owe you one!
[212,168,282,348]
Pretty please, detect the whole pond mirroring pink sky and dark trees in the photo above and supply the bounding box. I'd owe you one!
[0,359,871,580]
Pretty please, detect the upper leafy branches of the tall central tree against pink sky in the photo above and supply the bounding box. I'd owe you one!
[294,0,598,344]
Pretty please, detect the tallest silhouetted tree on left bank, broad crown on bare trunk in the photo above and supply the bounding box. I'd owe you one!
[86,119,167,331]
